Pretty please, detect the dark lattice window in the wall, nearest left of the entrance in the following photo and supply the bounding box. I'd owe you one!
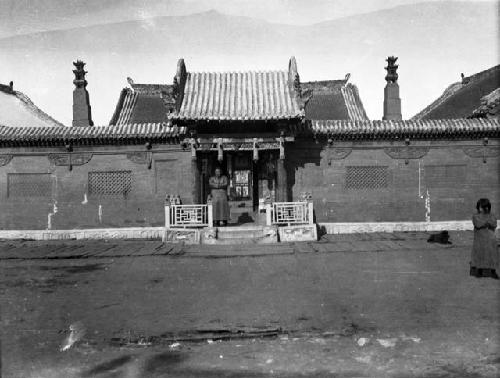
[88,171,132,197]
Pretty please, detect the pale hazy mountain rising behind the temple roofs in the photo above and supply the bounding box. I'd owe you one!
[0,0,498,124]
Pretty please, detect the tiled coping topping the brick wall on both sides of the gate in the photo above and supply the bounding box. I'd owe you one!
[0,118,500,147]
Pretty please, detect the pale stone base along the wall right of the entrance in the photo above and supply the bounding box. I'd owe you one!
[318,220,474,234]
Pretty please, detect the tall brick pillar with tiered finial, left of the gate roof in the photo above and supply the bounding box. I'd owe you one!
[73,60,94,126]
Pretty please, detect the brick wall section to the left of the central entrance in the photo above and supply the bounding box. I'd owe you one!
[0,145,192,229]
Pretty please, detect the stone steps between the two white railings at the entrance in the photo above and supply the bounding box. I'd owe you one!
[201,226,278,244]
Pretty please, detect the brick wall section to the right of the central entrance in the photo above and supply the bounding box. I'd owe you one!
[286,140,500,222]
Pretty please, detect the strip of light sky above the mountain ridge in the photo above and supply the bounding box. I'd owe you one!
[0,0,484,38]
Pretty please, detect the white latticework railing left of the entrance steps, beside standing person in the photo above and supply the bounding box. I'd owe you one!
[165,204,213,228]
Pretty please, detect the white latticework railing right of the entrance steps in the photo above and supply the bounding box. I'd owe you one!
[266,201,314,226]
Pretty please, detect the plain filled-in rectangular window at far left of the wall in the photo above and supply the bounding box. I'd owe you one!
[7,173,52,197]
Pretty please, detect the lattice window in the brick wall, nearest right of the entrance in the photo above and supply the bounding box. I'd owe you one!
[345,166,389,190]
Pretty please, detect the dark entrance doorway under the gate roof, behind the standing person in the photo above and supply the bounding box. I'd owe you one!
[200,150,277,225]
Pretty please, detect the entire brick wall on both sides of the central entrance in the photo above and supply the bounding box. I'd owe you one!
[0,138,500,229]
